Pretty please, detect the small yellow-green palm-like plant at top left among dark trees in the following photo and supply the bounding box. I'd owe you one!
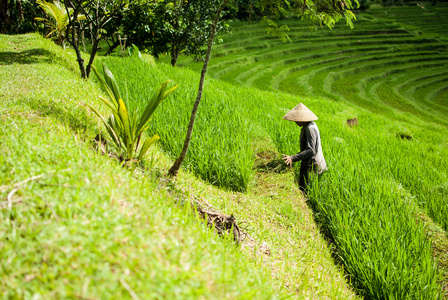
[35,0,85,45]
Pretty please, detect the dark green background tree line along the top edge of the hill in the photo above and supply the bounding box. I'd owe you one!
[4,0,448,49]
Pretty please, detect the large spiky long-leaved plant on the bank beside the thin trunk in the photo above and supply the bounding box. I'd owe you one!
[89,65,178,160]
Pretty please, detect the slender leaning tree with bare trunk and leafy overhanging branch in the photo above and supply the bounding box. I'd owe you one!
[168,0,357,176]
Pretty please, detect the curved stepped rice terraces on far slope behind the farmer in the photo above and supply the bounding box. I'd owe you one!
[179,6,448,125]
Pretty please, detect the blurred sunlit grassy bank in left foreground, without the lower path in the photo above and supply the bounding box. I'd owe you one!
[0,35,276,299]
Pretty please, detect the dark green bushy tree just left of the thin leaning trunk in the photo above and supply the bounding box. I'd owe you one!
[122,0,229,66]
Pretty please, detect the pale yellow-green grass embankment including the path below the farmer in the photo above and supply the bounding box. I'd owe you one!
[0,35,355,299]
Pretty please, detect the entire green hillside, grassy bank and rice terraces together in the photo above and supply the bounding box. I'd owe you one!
[0,4,448,299]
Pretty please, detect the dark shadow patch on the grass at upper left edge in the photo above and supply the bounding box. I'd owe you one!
[0,48,56,65]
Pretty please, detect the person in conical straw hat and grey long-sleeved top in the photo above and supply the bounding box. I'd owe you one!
[282,103,327,193]
